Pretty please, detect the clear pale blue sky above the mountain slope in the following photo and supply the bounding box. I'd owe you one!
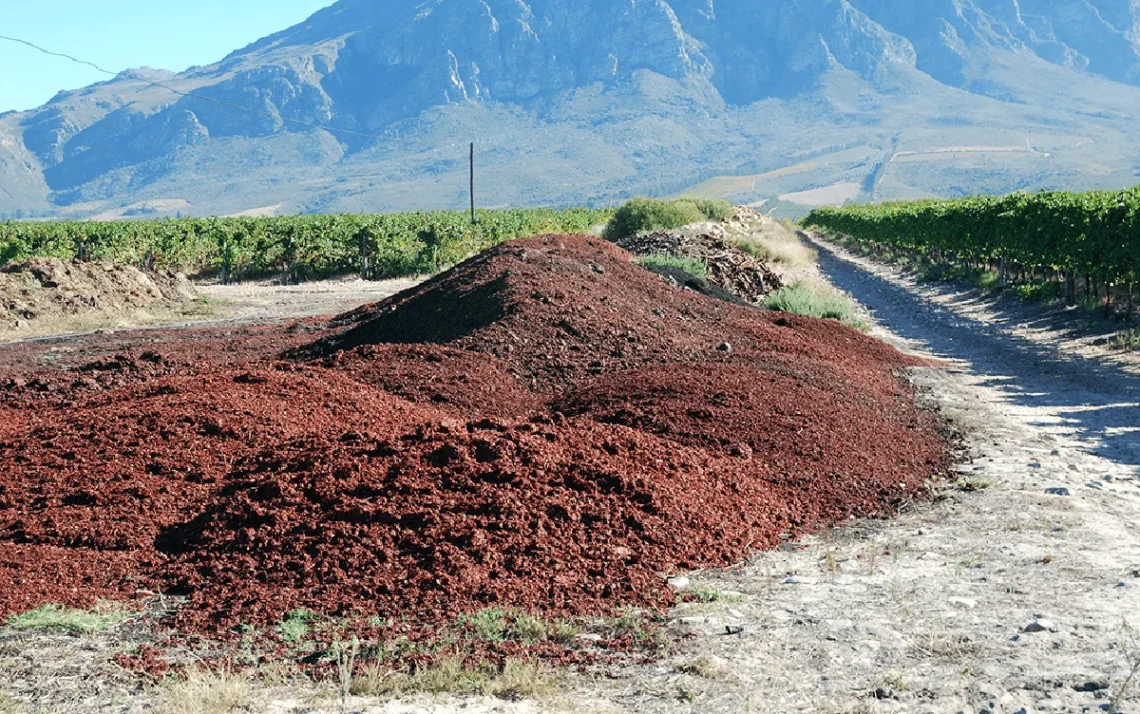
[0,0,335,112]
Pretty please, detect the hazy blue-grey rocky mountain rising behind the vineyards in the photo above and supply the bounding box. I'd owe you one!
[0,0,1140,218]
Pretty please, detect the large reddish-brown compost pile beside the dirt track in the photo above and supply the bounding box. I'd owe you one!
[0,236,946,633]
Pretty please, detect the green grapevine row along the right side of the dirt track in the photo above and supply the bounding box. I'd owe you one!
[804,187,1140,285]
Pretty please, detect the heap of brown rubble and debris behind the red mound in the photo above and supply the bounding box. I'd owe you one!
[618,228,783,303]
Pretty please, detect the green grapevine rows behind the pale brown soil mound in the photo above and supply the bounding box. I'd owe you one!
[0,209,610,279]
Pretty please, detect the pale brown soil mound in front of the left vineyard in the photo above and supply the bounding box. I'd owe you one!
[0,258,197,332]
